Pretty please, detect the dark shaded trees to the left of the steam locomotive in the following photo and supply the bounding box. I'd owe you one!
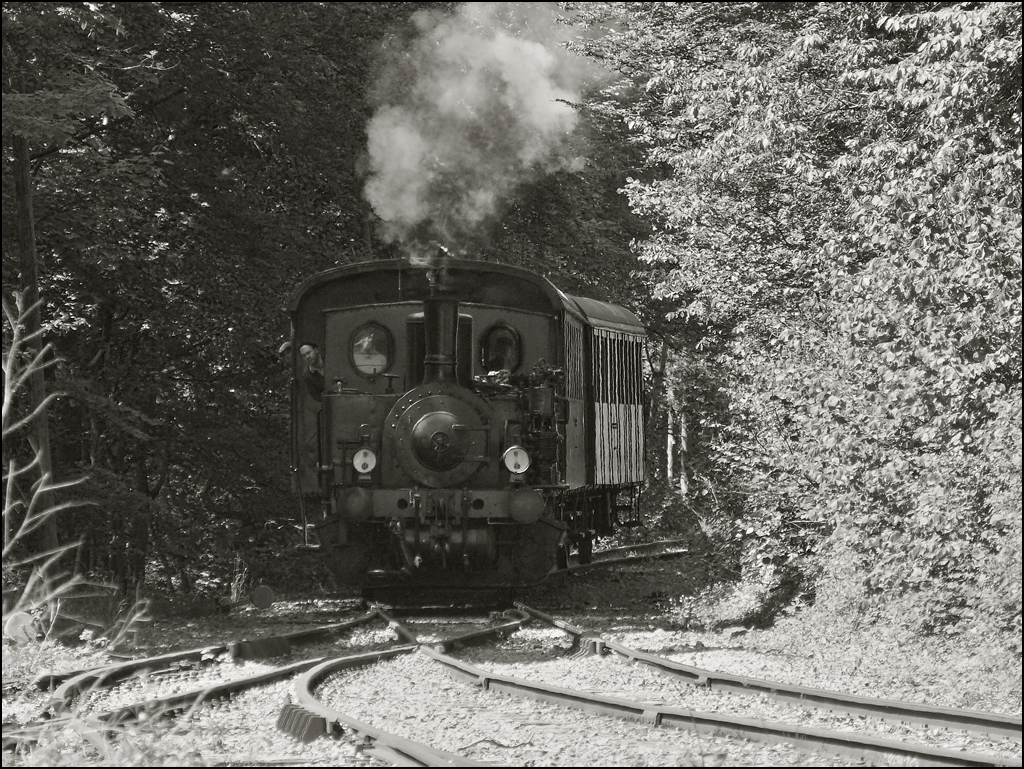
[4,3,421,582]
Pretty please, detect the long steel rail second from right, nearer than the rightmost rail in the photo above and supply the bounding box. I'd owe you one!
[418,646,1020,766]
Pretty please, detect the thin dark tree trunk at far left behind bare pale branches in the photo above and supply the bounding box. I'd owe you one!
[13,135,58,552]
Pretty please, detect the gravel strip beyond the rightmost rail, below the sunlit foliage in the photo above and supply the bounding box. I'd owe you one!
[522,561,1022,718]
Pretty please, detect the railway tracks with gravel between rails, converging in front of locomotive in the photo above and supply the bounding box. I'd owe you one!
[3,577,1021,766]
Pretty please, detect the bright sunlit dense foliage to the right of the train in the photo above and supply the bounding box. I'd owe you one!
[573,3,1021,631]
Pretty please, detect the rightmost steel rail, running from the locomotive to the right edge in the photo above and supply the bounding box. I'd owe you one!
[515,603,1021,742]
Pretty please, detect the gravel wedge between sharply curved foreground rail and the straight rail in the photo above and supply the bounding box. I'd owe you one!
[317,654,842,766]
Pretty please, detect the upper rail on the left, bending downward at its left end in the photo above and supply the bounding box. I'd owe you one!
[41,611,381,715]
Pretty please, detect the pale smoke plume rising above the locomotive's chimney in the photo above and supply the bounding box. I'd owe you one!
[364,3,594,254]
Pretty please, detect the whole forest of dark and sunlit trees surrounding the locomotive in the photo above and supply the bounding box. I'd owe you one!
[3,2,1022,653]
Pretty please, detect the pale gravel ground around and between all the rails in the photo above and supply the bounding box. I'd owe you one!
[3,560,1021,766]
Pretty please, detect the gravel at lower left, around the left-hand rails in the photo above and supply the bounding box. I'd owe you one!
[3,616,403,766]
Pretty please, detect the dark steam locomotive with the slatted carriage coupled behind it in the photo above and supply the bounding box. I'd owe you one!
[289,251,645,589]
